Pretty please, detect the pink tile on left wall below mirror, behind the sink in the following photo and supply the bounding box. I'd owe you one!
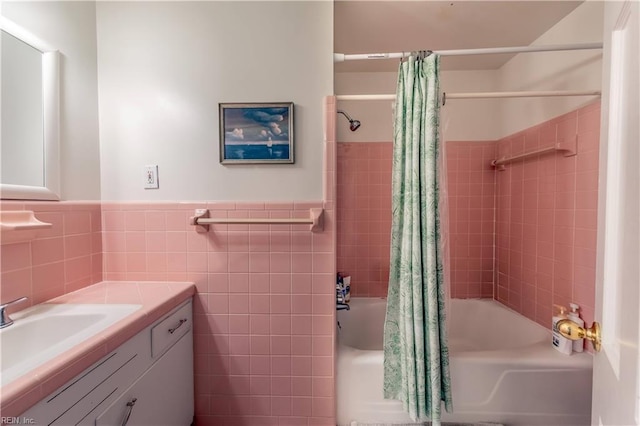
[0,201,102,311]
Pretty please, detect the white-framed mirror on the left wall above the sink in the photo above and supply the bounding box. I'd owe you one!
[0,17,60,200]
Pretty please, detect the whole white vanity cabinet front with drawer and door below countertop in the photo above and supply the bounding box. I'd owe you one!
[22,299,194,426]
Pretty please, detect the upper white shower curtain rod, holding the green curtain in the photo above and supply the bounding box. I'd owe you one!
[333,42,602,62]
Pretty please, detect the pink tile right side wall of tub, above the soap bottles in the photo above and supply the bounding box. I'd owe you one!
[496,103,600,326]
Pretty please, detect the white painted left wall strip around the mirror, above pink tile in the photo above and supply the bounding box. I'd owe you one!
[2,1,100,200]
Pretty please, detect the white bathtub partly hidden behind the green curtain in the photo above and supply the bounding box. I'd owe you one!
[336,298,592,426]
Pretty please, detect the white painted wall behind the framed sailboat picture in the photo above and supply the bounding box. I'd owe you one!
[97,1,333,201]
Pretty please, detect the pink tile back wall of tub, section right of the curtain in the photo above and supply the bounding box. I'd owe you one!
[445,141,496,299]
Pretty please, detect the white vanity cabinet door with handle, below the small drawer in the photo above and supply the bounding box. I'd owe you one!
[96,330,194,426]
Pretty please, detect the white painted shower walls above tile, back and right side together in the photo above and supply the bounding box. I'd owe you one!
[335,1,603,142]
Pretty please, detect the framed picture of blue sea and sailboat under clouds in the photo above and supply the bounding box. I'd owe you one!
[219,102,294,164]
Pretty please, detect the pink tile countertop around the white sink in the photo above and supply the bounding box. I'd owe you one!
[0,281,195,417]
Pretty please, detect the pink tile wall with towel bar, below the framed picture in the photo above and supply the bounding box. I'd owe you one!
[103,202,335,425]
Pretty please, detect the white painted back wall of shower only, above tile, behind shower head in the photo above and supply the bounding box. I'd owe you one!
[335,71,500,142]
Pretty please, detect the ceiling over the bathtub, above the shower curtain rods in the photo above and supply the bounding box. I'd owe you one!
[334,0,582,72]
